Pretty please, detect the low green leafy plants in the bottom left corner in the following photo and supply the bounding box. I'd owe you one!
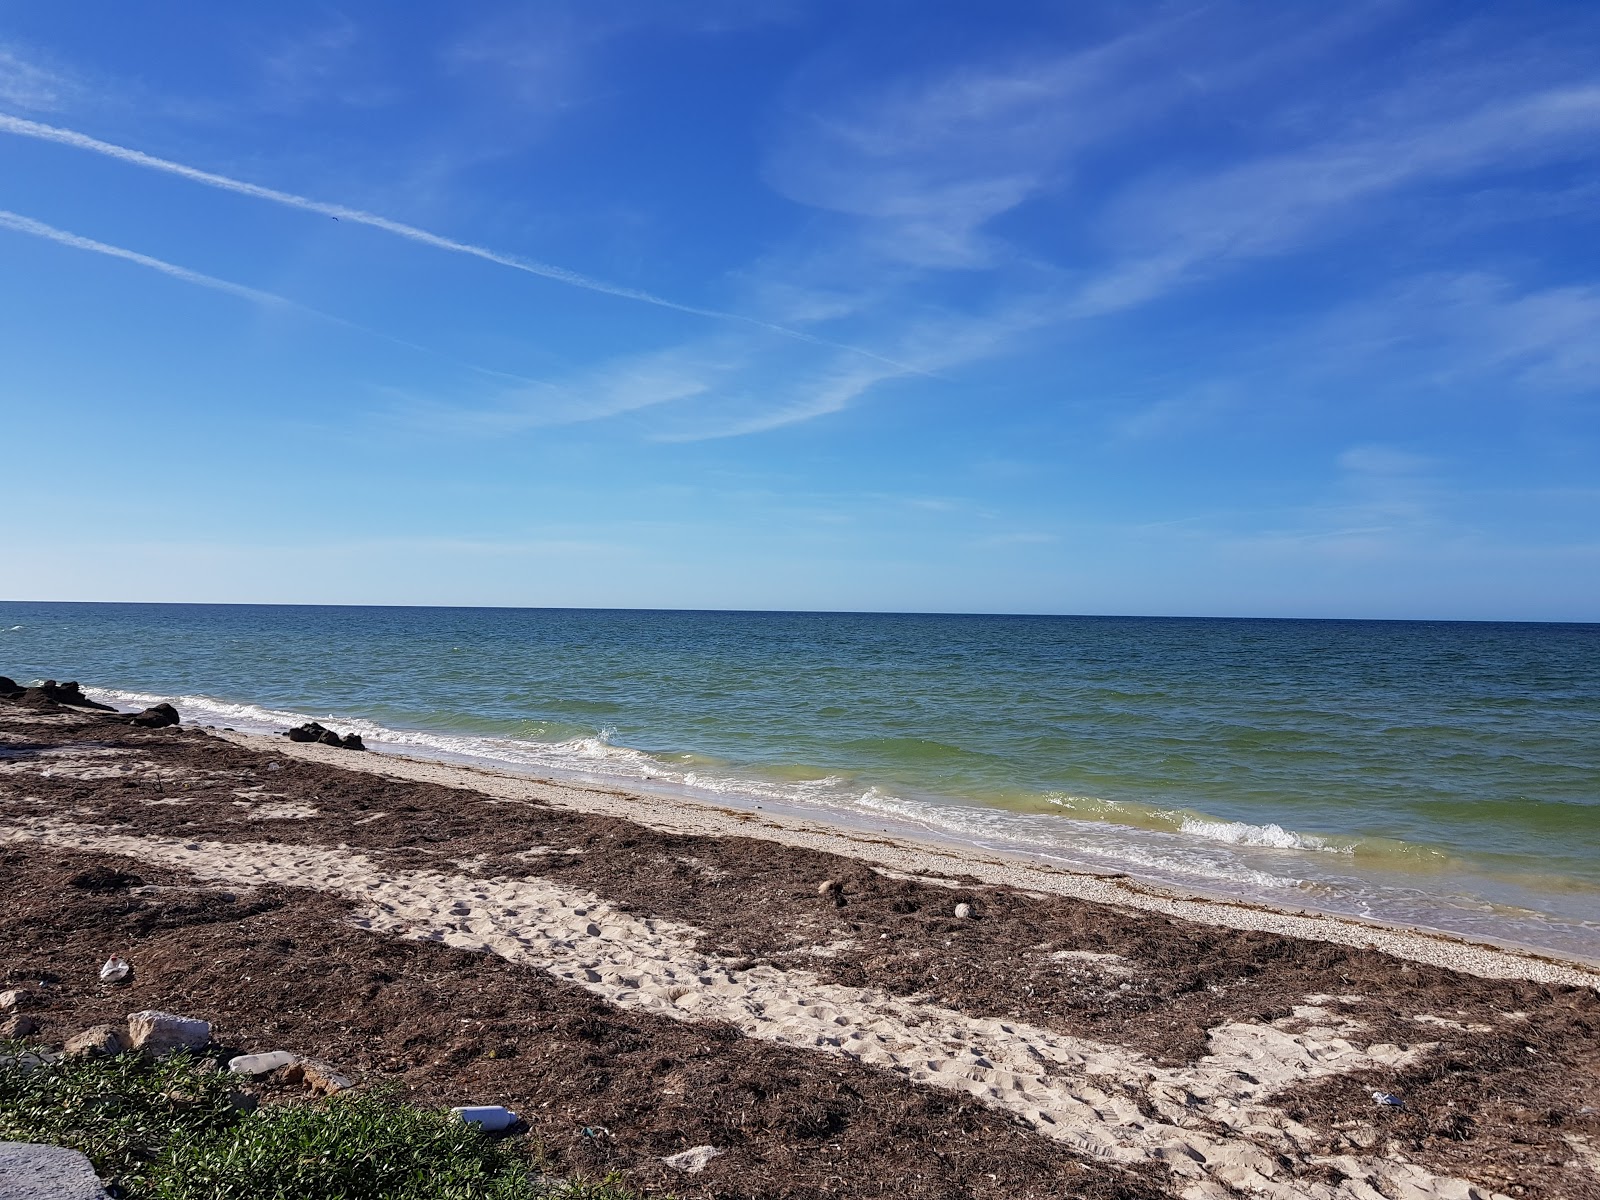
[0,1043,637,1200]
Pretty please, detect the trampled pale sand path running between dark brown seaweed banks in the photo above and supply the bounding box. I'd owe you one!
[0,818,1516,1200]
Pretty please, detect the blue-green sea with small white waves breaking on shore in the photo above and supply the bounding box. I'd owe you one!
[9,602,1600,957]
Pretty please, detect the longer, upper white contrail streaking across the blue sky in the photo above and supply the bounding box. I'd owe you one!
[0,114,926,374]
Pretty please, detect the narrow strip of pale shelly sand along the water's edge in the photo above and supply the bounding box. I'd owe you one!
[225,730,1600,989]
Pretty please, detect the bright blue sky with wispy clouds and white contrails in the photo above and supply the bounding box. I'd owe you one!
[0,0,1600,621]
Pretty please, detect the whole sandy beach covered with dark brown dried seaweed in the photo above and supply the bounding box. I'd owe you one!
[0,702,1600,1200]
